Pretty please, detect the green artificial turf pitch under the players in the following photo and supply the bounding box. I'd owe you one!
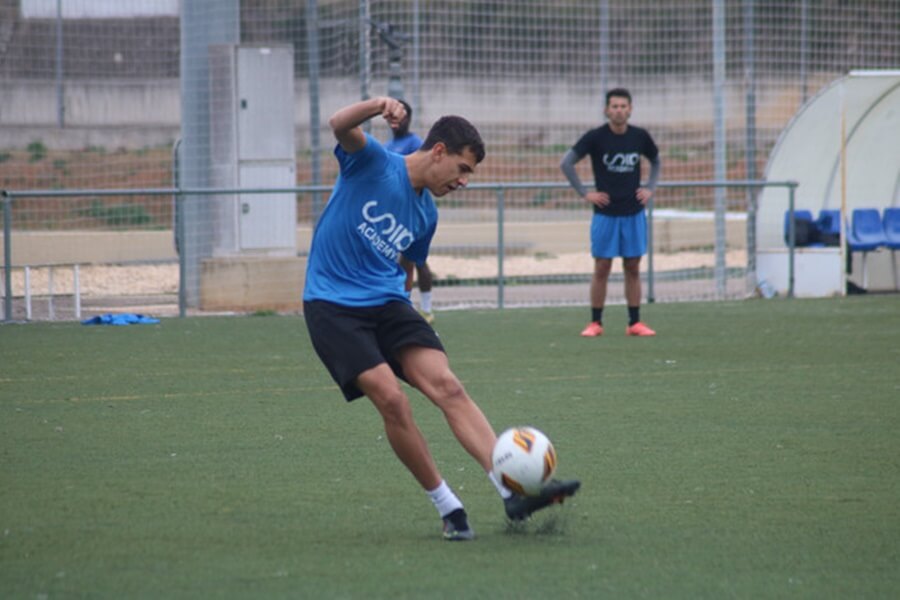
[0,295,900,599]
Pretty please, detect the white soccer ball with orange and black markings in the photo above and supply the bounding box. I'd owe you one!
[491,426,556,496]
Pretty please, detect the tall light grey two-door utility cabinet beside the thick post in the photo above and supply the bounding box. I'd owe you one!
[209,44,297,256]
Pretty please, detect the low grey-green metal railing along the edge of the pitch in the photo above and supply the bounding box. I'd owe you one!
[0,180,798,321]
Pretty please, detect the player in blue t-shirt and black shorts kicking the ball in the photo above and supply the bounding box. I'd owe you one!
[303,97,580,540]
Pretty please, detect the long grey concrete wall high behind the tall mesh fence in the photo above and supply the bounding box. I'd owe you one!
[0,77,832,149]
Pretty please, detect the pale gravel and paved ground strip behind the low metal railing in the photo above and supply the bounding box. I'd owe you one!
[5,250,746,320]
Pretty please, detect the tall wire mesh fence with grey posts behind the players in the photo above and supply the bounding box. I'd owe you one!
[0,0,900,316]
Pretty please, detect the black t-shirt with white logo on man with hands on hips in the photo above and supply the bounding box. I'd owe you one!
[572,124,659,216]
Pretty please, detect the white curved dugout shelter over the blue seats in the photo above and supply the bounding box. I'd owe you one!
[756,70,900,296]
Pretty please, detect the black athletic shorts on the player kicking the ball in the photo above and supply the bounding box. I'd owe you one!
[303,300,444,402]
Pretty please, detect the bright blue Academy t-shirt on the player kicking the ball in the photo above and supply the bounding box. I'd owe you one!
[303,134,438,306]
